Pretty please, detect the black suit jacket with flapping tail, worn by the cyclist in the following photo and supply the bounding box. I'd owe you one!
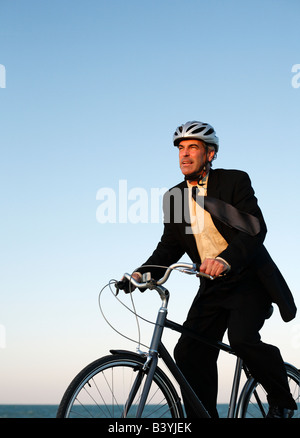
[138,169,296,321]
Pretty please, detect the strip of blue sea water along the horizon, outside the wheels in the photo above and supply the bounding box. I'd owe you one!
[0,405,228,419]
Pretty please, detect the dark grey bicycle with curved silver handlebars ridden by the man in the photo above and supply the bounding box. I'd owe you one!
[57,263,300,418]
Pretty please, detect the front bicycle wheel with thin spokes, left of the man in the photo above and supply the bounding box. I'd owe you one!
[57,352,183,418]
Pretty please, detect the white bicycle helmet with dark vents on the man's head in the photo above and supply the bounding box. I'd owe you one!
[173,121,219,152]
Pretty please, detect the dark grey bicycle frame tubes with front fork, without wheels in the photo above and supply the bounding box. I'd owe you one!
[122,278,249,418]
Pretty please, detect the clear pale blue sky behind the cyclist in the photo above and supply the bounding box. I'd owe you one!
[0,0,300,404]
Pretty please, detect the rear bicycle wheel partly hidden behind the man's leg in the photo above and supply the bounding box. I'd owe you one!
[236,363,300,418]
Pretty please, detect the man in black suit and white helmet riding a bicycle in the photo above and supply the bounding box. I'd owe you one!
[127,122,297,418]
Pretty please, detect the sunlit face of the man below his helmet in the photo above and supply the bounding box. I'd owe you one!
[178,140,213,175]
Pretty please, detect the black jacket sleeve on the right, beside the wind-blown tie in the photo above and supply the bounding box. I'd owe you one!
[219,171,267,270]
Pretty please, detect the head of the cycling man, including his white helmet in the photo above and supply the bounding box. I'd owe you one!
[173,121,219,176]
